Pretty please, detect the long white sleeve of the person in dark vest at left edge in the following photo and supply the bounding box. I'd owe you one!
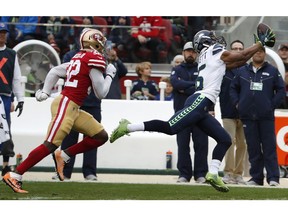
[12,55,24,102]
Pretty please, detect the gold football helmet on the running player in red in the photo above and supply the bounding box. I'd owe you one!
[79,28,107,54]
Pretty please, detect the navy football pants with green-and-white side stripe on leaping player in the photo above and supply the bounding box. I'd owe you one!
[144,94,232,161]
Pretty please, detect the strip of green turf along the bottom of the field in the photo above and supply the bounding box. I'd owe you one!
[0,181,288,200]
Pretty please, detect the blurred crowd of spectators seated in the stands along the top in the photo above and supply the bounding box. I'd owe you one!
[0,16,220,63]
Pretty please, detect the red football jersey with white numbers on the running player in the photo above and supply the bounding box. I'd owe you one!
[61,51,106,106]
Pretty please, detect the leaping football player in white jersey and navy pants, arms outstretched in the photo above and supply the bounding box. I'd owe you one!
[110,30,274,192]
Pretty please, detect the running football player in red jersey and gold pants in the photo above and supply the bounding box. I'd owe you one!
[3,28,116,193]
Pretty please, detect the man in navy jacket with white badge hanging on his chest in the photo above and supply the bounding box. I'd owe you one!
[230,47,285,186]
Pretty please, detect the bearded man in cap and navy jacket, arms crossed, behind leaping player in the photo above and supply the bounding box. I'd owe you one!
[170,41,208,183]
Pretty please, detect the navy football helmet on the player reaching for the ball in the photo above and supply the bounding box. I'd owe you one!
[193,30,227,53]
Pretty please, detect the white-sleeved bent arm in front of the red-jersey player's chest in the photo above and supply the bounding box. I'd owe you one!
[89,68,112,99]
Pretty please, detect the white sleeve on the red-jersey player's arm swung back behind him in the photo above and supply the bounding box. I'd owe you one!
[42,62,69,95]
